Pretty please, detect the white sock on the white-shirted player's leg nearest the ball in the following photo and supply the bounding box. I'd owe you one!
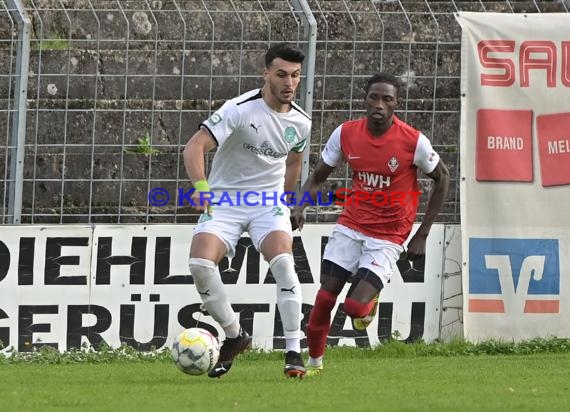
[189,258,240,338]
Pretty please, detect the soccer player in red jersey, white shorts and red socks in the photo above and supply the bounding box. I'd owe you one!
[292,73,449,375]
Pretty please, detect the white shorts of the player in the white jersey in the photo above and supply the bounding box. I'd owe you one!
[194,205,293,258]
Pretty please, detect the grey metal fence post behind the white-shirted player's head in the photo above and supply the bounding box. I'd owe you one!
[292,0,317,184]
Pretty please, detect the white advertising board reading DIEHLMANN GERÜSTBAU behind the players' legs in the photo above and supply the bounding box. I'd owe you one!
[0,224,445,351]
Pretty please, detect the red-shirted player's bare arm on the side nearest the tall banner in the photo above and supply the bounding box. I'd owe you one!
[407,159,449,260]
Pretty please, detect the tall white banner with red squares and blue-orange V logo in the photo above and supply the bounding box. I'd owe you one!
[457,13,570,341]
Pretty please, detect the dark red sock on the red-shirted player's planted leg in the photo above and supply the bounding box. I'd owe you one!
[307,289,337,358]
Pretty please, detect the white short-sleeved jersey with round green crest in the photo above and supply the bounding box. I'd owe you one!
[200,89,311,203]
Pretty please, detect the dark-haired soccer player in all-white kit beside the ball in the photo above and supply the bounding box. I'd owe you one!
[183,43,311,378]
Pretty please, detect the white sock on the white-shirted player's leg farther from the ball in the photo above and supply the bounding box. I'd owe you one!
[269,253,303,353]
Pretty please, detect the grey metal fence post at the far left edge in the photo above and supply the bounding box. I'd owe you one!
[6,0,32,224]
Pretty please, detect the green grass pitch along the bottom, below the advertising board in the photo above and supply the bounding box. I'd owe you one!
[0,340,570,412]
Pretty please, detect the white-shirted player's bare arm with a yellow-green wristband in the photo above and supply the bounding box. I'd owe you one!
[182,128,216,211]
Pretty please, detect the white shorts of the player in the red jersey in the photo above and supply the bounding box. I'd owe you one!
[323,224,404,286]
